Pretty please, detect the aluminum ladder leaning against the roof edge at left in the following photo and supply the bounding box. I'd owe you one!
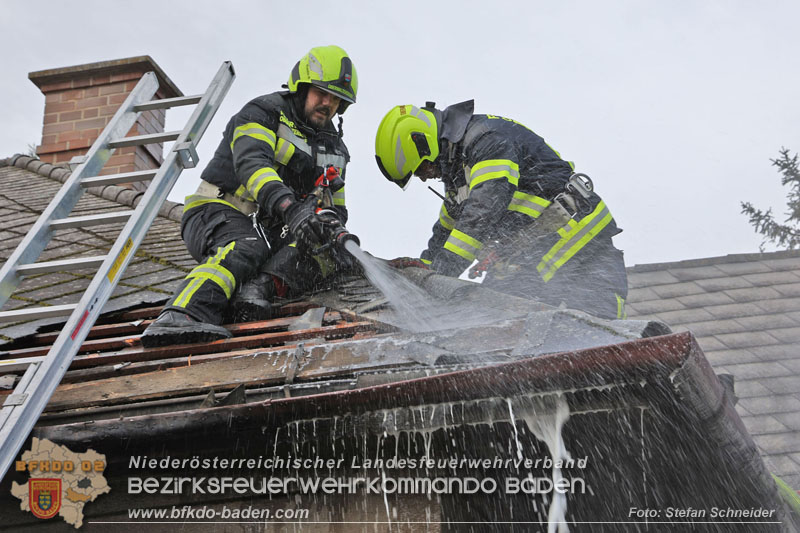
[0,61,236,479]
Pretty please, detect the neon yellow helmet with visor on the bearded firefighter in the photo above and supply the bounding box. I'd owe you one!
[287,45,358,114]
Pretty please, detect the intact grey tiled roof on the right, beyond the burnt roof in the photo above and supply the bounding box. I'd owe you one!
[628,251,800,489]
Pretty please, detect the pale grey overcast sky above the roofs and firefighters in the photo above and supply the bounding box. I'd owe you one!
[0,0,800,265]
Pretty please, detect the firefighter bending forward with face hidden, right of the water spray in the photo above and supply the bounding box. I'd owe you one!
[375,100,627,318]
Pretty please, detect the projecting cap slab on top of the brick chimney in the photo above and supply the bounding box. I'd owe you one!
[28,56,183,98]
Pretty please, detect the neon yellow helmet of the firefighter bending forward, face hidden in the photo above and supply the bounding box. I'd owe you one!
[375,105,439,189]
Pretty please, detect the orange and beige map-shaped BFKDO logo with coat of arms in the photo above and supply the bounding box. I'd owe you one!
[11,438,111,528]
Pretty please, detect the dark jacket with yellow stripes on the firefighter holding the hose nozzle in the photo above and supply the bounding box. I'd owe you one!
[189,91,350,237]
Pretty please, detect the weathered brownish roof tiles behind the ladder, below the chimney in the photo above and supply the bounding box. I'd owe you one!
[0,155,191,345]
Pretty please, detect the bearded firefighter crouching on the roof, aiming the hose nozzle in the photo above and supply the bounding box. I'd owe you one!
[142,46,358,346]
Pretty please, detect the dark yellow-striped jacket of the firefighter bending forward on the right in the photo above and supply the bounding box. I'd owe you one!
[421,100,620,282]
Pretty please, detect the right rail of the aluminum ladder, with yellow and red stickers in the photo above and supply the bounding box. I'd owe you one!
[0,61,235,477]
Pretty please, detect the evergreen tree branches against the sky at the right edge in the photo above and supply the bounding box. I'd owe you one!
[742,148,800,252]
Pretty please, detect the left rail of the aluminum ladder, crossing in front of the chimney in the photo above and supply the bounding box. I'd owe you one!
[0,72,158,306]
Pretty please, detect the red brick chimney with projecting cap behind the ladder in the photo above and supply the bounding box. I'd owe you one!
[28,56,183,183]
